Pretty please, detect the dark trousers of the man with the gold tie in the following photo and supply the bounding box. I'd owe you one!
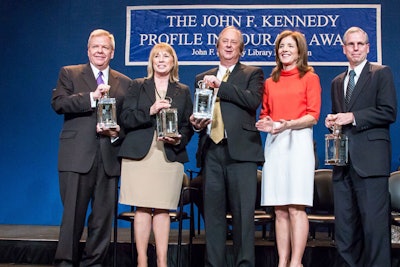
[203,142,257,267]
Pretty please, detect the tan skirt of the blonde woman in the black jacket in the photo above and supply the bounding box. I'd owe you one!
[119,134,183,209]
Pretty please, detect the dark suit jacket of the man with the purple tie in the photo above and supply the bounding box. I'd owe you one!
[51,63,132,176]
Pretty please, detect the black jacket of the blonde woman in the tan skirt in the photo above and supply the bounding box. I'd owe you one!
[119,78,193,163]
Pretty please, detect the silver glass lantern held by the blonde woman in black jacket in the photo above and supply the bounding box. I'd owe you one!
[156,108,179,137]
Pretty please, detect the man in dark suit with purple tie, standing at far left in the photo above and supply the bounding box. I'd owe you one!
[51,30,131,266]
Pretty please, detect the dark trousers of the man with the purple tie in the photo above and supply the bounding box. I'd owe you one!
[55,153,118,266]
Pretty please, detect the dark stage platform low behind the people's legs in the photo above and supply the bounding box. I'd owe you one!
[0,225,400,267]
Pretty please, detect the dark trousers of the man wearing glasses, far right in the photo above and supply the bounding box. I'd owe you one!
[333,165,391,267]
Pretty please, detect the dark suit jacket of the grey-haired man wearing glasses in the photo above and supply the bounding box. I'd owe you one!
[331,62,397,177]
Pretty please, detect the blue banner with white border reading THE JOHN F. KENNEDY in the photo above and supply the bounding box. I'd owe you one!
[125,4,382,66]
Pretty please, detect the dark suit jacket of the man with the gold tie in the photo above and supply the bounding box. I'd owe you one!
[195,62,264,167]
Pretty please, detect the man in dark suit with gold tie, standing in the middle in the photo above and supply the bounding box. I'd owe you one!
[191,26,264,267]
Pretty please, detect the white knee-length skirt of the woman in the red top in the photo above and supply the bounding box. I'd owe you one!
[261,128,315,206]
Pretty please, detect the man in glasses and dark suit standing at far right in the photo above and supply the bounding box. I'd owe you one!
[325,27,397,266]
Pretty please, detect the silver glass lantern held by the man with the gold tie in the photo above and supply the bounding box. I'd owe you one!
[193,80,215,119]
